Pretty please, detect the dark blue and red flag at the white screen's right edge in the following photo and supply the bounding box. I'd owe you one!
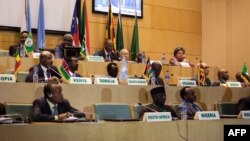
[71,1,81,47]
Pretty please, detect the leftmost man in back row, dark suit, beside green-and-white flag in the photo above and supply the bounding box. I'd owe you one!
[9,31,29,57]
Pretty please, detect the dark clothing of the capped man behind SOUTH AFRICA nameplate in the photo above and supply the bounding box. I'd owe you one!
[139,104,177,120]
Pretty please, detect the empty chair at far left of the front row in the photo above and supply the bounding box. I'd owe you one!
[4,102,32,122]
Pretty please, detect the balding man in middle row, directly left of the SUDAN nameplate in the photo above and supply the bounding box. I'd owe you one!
[213,69,229,86]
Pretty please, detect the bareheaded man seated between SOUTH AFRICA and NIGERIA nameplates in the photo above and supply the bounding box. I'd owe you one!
[177,86,202,118]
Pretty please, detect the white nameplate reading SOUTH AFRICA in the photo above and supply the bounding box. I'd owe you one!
[143,112,172,122]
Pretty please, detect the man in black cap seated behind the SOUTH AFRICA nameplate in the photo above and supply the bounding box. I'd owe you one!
[139,86,177,119]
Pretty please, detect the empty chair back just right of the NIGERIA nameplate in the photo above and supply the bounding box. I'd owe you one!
[216,102,237,117]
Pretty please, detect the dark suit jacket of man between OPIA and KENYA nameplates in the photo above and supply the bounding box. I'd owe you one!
[25,64,61,82]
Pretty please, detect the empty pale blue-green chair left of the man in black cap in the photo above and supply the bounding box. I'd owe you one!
[94,103,132,120]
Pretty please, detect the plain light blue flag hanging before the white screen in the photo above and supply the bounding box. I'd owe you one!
[36,0,45,49]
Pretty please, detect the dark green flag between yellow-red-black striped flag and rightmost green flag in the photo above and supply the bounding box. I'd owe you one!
[116,0,124,51]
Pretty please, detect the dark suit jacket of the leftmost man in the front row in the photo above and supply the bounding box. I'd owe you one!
[32,97,85,121]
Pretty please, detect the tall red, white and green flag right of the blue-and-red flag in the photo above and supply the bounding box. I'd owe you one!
[81,0,90,56]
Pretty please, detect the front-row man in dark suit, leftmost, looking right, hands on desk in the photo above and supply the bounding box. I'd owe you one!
[32,77,85,121]
